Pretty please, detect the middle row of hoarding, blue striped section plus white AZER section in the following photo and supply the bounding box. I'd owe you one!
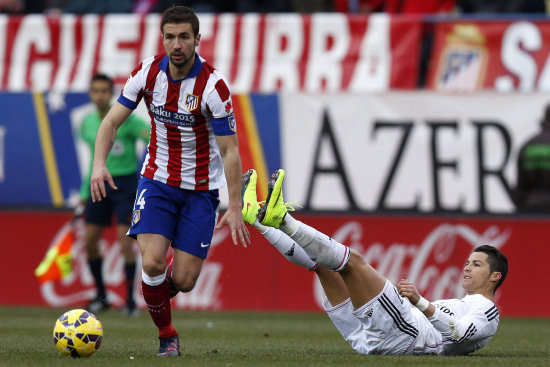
[0,91,548,214]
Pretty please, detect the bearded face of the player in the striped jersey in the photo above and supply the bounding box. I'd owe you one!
[162,23,201,68]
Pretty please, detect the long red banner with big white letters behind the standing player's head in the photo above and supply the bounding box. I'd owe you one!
[0,14,421,94]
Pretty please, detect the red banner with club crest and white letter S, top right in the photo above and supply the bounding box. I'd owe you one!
[428,19,550,92]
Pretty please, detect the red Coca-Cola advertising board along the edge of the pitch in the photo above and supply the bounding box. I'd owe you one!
[0,211,550,317]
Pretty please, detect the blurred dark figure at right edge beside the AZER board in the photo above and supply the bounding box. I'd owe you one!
[513,105,550,213]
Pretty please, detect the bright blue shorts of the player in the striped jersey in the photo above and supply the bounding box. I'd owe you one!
[128,177,220,259]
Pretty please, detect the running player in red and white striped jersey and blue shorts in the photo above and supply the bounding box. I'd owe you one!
[90,6,250,356]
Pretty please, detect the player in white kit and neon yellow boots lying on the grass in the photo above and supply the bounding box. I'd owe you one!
[241,169,508,355]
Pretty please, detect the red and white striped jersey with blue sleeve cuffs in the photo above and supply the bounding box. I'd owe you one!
[118,54,236,190]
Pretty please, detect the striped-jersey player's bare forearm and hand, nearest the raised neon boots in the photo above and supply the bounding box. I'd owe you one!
[216,134,250,247]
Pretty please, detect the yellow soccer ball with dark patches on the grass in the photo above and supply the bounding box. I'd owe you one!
[53,309,103,357]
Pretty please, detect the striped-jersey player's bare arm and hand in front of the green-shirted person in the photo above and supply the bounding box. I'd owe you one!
[90,102,132,202]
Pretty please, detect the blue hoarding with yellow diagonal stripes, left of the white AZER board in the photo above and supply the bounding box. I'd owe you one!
[0,92,281,207]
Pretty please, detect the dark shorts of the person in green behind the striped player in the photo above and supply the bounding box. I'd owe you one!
[84,174,138,226]
